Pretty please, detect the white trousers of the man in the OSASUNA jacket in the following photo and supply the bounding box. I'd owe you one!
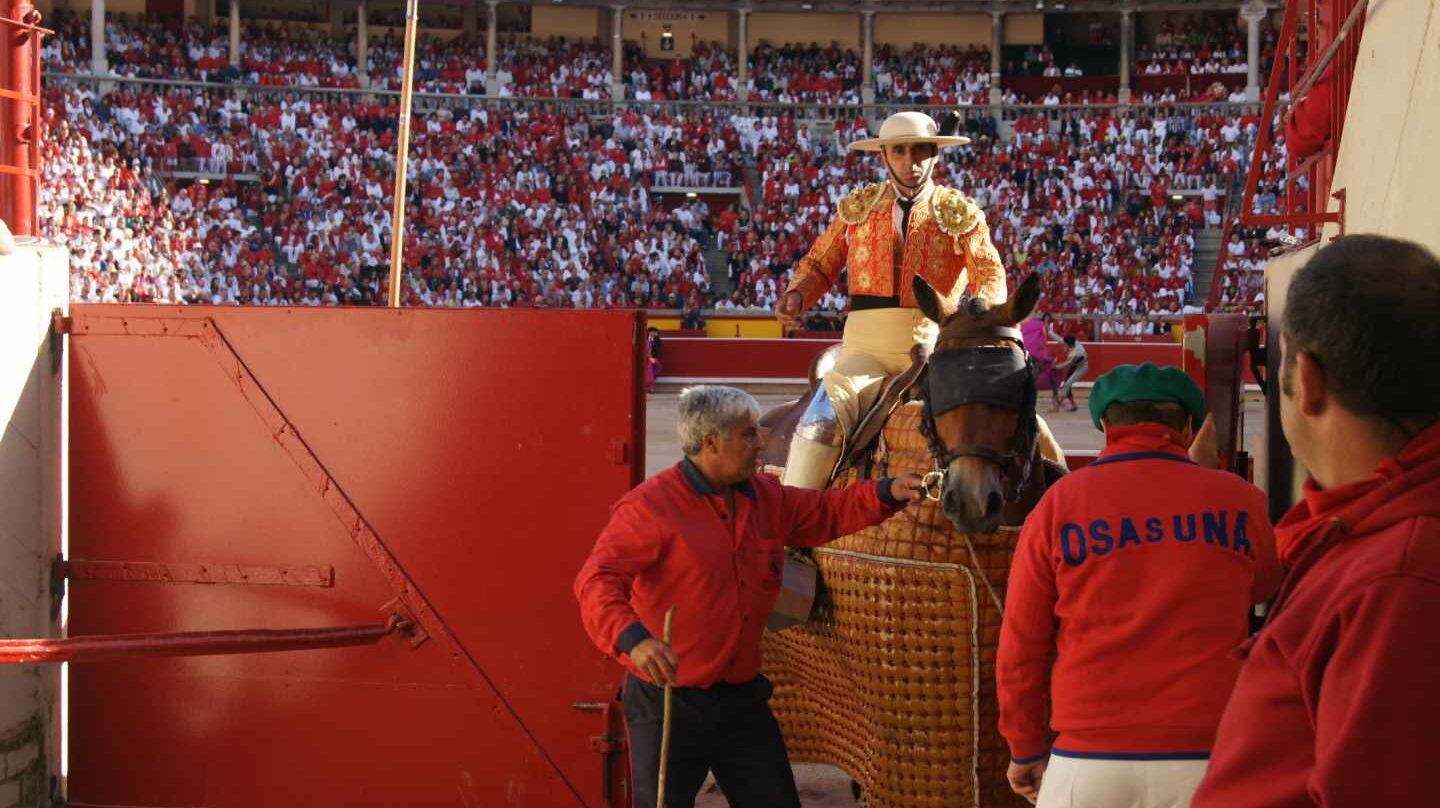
[1035,755,1208,808]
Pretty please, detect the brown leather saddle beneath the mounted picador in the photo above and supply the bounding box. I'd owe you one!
[760,339,930,480]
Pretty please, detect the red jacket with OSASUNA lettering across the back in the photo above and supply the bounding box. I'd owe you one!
[995,423,1280,762]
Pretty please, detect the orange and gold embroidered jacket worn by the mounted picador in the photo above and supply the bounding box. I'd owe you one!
[785,183,1007,308]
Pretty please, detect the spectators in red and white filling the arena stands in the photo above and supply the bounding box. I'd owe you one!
[42,11,1273,321]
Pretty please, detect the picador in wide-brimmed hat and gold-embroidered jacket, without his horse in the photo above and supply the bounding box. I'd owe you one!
[776,112,1007,488]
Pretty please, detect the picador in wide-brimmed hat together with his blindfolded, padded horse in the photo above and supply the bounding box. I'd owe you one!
[763,112,1064,808]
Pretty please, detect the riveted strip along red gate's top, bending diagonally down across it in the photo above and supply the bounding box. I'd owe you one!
[66,315,586,805]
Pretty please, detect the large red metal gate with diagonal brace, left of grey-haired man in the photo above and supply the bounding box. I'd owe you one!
[68,305,644,808]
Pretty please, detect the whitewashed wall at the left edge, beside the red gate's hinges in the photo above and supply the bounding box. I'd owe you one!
[0,248,69,808]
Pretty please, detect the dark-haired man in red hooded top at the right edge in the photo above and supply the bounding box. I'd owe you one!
[1194,236,1440,808]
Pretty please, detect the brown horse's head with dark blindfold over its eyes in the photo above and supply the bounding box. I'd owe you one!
[914,274,1040,533]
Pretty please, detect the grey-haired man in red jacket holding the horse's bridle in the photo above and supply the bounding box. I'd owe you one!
[575,386,923,808]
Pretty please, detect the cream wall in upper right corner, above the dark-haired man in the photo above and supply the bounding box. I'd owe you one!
[1324,3,1440,254]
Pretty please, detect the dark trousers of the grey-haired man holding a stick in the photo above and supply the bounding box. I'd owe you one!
[624,675,801,808]
